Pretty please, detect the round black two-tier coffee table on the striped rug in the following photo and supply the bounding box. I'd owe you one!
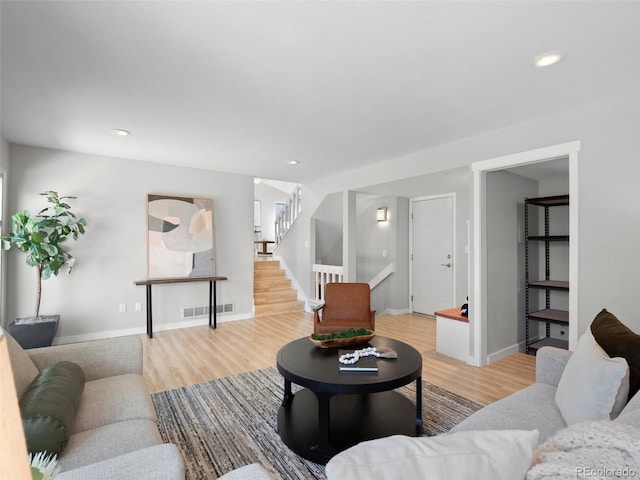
[277,336,422,464]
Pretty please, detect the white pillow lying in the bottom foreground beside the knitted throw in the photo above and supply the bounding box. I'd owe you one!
[326,430,538,480]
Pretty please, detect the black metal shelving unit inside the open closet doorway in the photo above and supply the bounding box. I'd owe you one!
[524,195,569,354]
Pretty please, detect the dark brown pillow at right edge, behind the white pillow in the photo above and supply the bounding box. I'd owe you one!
[591,308,640,400]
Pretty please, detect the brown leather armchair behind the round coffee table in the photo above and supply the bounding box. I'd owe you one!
[313,283,376,334]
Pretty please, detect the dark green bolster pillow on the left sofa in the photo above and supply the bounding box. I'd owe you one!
[20,362,84,454]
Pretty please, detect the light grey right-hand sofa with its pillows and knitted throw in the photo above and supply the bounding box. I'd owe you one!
[326,310,640,480]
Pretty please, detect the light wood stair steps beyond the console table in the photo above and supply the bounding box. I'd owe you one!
[253,259,304,317]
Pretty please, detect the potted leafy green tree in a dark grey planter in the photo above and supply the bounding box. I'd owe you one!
[0,190,87,348]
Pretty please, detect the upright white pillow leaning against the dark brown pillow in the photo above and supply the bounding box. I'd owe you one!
[555,329,629,425]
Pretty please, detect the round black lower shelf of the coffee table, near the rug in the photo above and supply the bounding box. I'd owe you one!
[278,389,422,464]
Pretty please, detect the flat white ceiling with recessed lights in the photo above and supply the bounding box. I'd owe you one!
[0,0,640,182]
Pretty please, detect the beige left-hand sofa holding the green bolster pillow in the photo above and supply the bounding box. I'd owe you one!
[7,335,184,480]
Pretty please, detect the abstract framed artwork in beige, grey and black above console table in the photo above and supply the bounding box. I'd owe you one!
[147,193,215,278]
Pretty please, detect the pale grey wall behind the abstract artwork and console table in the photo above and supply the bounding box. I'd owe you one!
[7,145,254,343]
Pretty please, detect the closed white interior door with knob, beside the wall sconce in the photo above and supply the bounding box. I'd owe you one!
[411,196,455,315]
